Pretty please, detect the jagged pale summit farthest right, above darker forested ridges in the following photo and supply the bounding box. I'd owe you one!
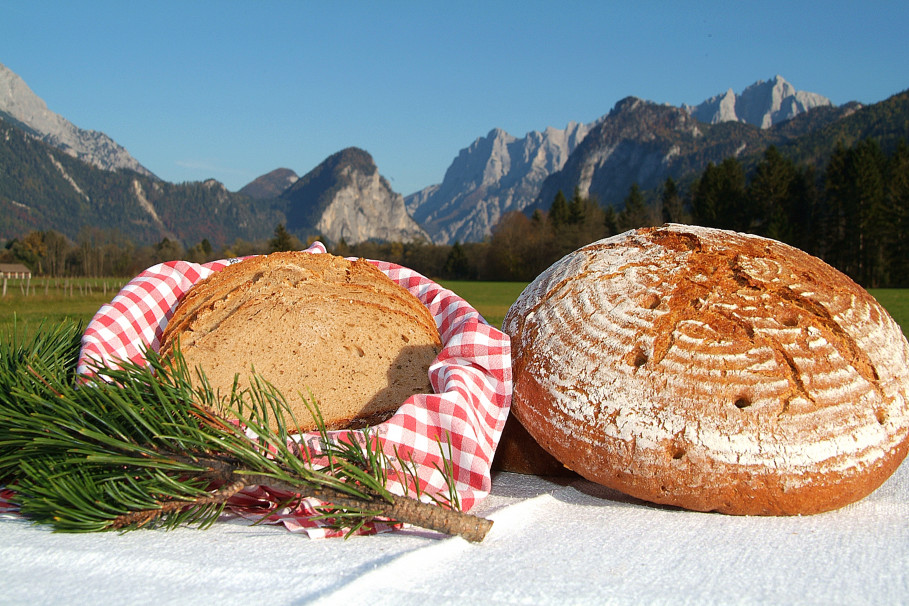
[683,76,833,128]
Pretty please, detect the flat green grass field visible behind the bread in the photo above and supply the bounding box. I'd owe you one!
[0,278,909,337]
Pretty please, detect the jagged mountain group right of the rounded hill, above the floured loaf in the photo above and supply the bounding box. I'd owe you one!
[406,76,833,243]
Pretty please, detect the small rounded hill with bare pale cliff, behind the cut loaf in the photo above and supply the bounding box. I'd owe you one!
[281,147,430,244]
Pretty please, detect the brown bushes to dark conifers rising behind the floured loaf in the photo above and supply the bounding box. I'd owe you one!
[452,139,909,288]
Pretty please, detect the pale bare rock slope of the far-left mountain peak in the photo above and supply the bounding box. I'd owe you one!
[0,64,154,177]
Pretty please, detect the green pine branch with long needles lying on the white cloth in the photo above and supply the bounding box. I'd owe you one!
[0,320,491,541]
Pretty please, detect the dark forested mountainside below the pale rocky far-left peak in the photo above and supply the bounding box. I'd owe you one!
[0,119,282,246]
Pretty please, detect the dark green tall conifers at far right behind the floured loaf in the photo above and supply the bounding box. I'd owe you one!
[689,139,909,288]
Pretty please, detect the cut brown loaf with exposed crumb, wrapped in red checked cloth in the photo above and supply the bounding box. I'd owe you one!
[160,252,441,431]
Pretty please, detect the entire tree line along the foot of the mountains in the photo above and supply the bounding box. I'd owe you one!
[0,139,909,287]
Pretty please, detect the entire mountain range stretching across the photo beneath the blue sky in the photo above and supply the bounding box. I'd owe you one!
[0,65,909,251]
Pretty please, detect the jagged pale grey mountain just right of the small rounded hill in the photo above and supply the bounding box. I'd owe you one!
[406,122,590,243]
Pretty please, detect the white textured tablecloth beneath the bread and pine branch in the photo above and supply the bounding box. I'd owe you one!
[0,465,909,606]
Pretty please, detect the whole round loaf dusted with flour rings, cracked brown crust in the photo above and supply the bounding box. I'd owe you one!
[504,225,909,515]
